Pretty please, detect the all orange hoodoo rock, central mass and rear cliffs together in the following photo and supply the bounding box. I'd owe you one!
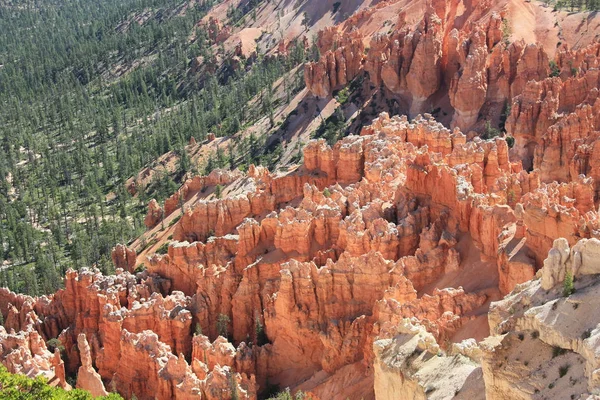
[0,5,600,399]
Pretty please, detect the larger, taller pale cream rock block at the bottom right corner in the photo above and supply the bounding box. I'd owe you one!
[481,239,600,399]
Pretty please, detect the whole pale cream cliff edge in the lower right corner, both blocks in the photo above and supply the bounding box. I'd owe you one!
[374,239,600,399]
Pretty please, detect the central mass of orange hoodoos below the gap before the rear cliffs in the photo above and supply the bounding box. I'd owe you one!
[0,108,576,398]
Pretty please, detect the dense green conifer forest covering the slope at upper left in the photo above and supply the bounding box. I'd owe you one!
[0,0,308,295]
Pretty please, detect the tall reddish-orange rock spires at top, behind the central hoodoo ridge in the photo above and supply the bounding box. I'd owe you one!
[312,2,556,133]
